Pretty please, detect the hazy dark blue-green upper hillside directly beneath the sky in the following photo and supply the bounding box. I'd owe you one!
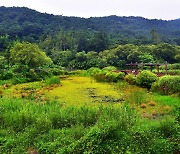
[0,7,180,45]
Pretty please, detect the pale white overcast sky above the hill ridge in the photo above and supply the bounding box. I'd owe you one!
[0,0,180,20]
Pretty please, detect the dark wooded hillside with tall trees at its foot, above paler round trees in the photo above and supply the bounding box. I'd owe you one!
[0,7,180,47]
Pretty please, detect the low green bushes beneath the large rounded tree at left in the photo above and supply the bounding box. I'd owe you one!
[0,65,64,84]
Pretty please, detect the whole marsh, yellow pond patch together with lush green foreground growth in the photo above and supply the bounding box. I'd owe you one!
[0,76,180,154]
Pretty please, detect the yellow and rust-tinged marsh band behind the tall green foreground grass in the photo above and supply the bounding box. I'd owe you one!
[3,76,180,118]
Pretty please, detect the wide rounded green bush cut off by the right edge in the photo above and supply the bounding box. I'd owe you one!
[152,76,180,94]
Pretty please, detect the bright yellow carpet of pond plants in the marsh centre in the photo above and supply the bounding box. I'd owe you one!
[46,77,122,106]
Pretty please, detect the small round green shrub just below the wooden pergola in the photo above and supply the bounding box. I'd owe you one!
[136,70,158,89]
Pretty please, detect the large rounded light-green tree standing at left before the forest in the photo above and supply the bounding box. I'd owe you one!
[10,42,52,68]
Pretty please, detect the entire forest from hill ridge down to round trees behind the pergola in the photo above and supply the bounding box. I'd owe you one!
[0,7,180,69]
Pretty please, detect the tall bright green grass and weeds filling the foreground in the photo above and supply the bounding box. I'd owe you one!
[0,98,179,154]
